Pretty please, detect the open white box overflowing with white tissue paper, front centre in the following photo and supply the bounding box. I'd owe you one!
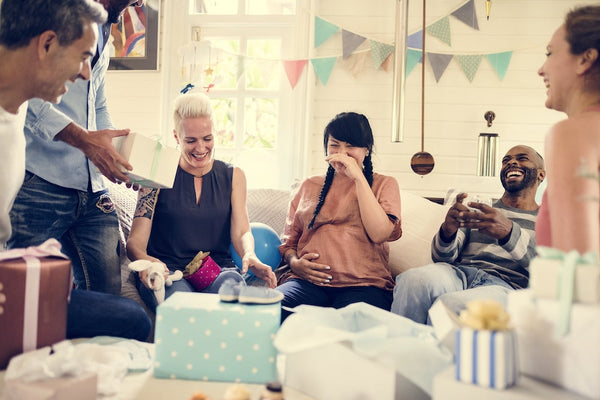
[275,303,452,400]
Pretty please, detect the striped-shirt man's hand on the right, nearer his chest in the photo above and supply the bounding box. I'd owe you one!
[460,202,513,242]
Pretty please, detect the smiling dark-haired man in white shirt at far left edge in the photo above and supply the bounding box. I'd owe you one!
[0,0,152,341]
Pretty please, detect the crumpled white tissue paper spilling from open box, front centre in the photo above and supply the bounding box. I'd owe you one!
[274,303,452,394]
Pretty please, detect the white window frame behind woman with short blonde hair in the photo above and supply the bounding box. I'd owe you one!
[162,0,314,189]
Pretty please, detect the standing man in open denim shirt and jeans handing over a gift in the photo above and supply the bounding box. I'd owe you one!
[8,0,142,294]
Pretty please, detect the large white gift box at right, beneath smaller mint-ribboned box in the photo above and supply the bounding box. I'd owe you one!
[508,289,600,399]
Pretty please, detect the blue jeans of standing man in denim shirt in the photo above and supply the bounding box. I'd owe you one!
[8,172,121,294]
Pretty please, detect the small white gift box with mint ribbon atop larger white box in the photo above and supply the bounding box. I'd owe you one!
[529,257,600,304]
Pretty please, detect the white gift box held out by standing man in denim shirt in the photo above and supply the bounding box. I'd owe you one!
[117,132,180,188]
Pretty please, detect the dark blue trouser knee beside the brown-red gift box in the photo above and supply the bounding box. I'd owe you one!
[67,290,152,341]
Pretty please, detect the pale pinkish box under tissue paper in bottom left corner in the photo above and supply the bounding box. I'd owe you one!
[3,372,97,400]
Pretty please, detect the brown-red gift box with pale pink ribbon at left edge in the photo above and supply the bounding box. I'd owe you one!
[0,239,73,369]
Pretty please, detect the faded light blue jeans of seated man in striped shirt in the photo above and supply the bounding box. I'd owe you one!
[391,263,512,325]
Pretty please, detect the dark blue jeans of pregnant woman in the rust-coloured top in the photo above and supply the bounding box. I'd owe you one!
[276,278,392,322]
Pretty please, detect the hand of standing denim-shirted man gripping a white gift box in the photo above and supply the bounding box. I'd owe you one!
[81,129,133,182]
